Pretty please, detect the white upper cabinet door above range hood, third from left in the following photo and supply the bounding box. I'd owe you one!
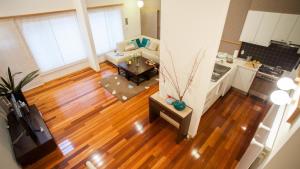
[272,14,298,42]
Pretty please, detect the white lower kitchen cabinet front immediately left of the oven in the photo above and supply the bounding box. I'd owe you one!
[232,66,256,93]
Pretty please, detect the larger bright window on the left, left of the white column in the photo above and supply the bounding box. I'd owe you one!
[17,12,87,72]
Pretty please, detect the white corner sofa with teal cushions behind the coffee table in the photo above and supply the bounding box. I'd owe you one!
[105,35,160,65]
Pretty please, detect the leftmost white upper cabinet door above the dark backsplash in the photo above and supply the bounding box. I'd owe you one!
[240,11,263,43]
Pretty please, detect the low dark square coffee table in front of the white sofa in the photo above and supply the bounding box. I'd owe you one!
[118,56,157,85]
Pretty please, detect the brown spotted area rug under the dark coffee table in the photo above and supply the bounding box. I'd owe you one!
[100,75,159,102]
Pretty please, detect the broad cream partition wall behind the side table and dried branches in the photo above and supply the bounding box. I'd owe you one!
[160,0,229,136]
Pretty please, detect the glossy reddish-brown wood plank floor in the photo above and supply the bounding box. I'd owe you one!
[25,63,269,169]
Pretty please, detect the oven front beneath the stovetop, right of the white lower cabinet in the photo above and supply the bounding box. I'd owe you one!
[249,72,278,101]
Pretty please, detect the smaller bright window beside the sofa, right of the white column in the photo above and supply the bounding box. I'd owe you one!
[88,7,124,55]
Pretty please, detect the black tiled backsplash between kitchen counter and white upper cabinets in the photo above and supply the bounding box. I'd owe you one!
[238,42,300,71]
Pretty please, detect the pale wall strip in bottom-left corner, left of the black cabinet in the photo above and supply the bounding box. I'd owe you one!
[0,107,20,169]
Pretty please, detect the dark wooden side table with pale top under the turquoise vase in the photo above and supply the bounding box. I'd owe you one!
[149,92,193,143]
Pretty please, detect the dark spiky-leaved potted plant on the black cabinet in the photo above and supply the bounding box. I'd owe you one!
[0,67,39,105]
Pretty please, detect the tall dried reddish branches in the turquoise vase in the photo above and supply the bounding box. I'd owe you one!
[160,45,205,101]
